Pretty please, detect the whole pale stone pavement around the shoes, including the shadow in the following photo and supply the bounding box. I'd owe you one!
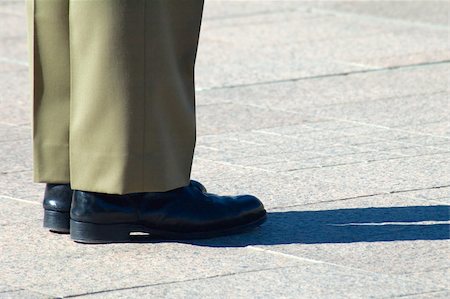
[0,0,450,299]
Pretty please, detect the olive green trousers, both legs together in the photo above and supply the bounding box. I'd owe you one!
[27,0,203,194]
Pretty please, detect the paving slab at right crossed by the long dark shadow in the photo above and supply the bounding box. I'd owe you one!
[229,195,450,288]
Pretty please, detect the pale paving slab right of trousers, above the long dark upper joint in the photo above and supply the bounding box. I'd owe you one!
[197,2,450,88]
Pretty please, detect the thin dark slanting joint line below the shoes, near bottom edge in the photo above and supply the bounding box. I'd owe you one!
[62,265,299,298]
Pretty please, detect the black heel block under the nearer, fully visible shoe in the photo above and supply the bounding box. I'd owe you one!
[70,219,131,244]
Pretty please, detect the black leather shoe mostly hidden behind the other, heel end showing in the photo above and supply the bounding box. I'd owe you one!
[43,184,73,234]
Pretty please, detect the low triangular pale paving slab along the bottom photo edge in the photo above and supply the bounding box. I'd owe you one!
[81,263,443,298]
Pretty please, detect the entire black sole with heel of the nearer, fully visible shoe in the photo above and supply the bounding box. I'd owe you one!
[70,215,267,244]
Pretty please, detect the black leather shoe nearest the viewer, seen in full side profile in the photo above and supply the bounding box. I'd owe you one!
[70,181,266,243]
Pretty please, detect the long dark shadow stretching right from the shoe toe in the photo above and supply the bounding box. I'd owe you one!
[137,205,450,247]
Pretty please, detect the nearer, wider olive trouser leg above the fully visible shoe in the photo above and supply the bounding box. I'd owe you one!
[69,0,203,194]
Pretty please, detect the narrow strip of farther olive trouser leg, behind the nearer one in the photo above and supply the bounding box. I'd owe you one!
[27,0,70,183]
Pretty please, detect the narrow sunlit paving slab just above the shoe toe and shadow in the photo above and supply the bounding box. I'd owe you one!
[193,154,450,208]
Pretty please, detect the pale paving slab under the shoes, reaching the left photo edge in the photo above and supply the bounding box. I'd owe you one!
[0,198,303,296]
